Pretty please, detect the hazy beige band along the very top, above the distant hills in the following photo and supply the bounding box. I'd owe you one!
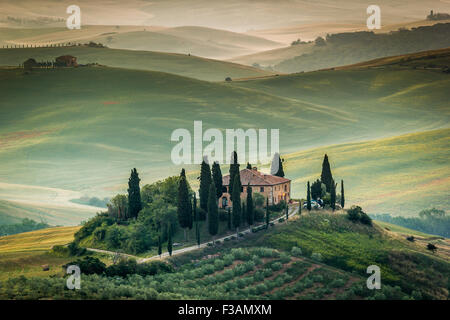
[0,0,450,31]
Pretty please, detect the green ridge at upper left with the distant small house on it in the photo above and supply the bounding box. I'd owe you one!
[0,47,272,81]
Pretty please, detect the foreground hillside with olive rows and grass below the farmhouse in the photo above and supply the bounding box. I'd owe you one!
[0,213,450,300]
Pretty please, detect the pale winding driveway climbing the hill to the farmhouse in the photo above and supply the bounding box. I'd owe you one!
[86,205,298,263]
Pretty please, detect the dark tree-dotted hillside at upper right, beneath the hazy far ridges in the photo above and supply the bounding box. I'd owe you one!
[241,22,450,73]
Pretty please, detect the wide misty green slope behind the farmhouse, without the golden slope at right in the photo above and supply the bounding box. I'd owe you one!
[0,49,449,215]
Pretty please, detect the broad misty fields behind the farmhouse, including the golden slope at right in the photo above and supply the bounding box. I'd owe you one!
[0,49,450,220]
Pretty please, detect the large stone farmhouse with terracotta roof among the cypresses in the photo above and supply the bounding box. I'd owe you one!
[219,167,291,208]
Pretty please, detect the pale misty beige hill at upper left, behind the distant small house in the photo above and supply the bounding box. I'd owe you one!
[0,25,282,59]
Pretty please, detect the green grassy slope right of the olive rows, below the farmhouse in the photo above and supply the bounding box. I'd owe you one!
[249,212,450,299]
